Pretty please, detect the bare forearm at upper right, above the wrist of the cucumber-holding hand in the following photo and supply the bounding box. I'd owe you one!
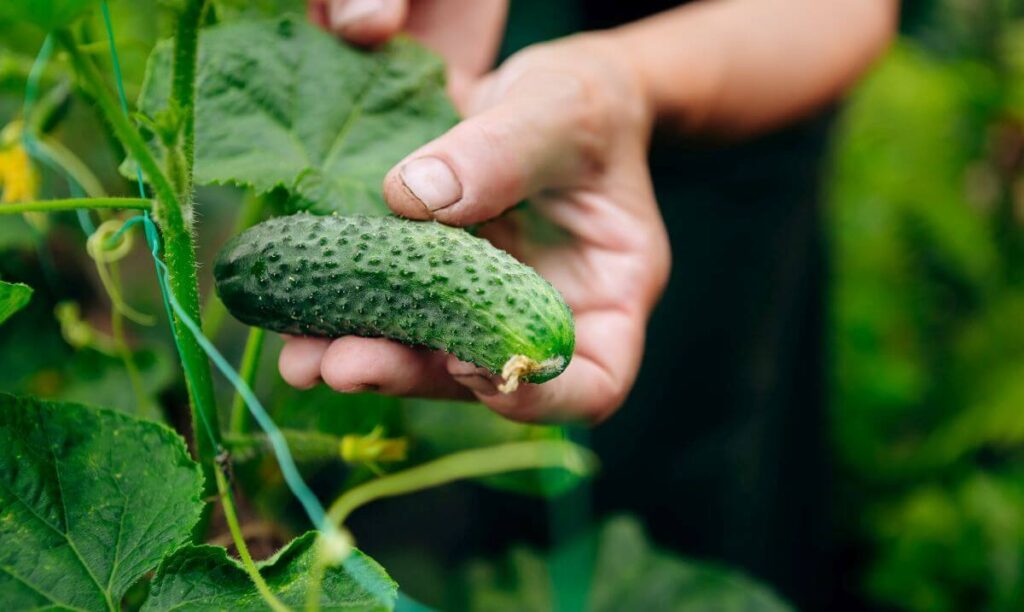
[608,0,897,136]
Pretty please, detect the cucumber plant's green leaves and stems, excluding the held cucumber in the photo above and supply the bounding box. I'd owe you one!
[0,0,590,610]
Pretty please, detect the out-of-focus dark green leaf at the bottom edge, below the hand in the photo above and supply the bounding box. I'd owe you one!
[462,517,792,612]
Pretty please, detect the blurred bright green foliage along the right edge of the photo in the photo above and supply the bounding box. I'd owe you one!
[828,0,1024,610]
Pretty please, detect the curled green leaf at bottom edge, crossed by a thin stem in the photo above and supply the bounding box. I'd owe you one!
[142,531,398,610]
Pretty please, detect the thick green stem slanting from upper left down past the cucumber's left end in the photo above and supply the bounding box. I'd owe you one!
[55,30,220,495]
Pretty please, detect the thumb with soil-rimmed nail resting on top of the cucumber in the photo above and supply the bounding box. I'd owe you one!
[384,69,586,225]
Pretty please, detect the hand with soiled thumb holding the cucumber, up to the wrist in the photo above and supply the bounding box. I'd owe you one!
[280,22,670,422]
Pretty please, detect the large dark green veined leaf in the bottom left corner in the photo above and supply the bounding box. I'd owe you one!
[0,394,202,610]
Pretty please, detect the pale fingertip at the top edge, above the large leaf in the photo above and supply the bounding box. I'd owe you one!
[310,0,409,46]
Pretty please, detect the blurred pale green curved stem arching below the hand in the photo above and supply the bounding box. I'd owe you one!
[328,440,596,525]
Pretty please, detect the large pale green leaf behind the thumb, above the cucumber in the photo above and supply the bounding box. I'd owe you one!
[139,16,458,214]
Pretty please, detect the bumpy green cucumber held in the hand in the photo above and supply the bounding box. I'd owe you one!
[214,213,575,383]
